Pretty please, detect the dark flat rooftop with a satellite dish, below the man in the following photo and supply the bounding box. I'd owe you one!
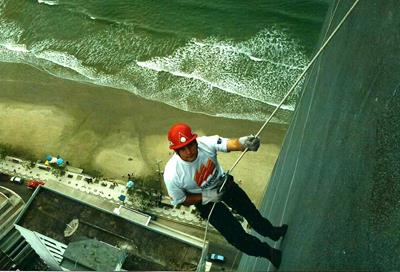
[16,186,202,270]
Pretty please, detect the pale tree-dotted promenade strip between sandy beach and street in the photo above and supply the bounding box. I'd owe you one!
[0,157,205,227]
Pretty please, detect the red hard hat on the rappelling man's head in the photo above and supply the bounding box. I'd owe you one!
[168,123,197,150]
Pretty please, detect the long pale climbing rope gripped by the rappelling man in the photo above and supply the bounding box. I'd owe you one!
[198,0,360,268]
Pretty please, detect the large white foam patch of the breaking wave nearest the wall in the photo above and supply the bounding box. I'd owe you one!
[137,26,306,110]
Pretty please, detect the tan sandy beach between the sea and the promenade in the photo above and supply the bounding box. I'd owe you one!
[0,63,286,204]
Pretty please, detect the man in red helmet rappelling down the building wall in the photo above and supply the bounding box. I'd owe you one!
[164,123,288,268]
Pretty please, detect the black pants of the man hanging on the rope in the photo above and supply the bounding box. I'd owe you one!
[195,176,275,259]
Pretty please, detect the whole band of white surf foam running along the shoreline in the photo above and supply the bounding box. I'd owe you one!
[0,18,306,120]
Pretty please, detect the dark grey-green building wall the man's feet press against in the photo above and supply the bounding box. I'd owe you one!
[239,0,400,271]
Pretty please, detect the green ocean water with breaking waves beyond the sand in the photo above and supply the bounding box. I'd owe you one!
[0,0,329,121]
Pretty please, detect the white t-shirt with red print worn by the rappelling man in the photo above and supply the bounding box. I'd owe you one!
[164,135,228,205]
